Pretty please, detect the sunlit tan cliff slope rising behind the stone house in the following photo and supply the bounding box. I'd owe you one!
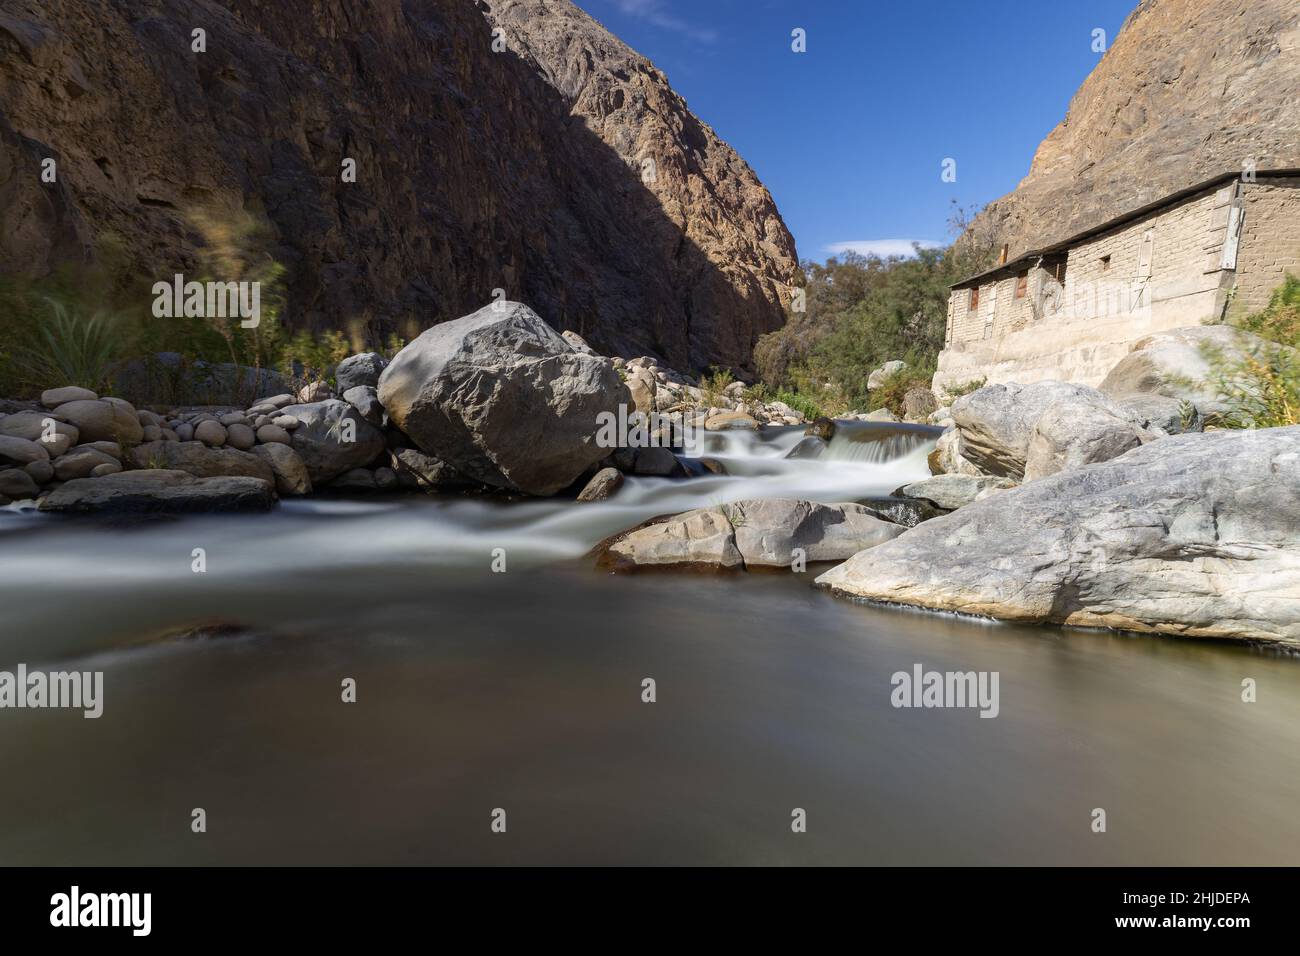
[972,0,1300,259]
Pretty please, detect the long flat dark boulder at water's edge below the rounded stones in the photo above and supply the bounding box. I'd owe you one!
[39,470,276,515]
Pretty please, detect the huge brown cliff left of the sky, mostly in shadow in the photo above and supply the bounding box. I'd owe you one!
[0,0,797,368]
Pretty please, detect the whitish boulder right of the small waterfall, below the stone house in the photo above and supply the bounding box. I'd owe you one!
[953,381,1151,480]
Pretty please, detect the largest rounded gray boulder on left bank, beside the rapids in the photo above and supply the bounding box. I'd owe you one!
[377,302,631,496]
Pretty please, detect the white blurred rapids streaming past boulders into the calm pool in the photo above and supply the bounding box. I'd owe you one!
[0,423,940,588]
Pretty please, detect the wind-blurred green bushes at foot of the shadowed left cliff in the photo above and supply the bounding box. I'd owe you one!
[0,212,404,405]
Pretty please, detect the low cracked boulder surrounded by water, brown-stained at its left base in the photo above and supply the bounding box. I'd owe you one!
[599,498,905,570]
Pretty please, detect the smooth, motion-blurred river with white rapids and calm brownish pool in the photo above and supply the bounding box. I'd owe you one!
[0,425,1300,865]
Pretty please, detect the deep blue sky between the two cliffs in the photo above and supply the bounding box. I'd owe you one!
[576,0,1136,261]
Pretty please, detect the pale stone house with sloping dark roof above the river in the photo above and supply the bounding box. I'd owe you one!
[933,170,1300,392]
